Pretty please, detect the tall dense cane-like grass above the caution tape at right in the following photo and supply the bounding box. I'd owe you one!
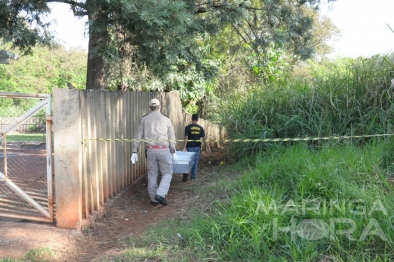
[219,56,394,159]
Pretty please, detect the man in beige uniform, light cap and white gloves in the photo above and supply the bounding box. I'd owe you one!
[131,98,177,206]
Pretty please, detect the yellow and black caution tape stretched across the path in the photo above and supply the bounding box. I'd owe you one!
[82,134,394,144]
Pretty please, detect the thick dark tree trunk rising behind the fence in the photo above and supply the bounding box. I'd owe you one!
[86,6,108,90]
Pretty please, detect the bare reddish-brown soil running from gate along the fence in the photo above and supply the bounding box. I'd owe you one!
[0,148,228,262]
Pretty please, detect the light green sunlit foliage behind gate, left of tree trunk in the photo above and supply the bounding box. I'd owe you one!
[0,47,87,94]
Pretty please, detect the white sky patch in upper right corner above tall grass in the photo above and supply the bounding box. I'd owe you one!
[321,0,394,57]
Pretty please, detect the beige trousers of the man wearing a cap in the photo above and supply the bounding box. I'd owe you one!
[147,148,173,202]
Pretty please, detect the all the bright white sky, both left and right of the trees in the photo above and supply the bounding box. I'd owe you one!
[48,0,394,57]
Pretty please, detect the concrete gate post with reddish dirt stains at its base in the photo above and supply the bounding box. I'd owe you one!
[53,88,82,228]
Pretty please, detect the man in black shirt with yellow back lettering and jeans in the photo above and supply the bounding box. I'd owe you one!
[183,114,211,182]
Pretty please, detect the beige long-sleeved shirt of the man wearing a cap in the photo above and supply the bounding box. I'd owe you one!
[133,111,176,154]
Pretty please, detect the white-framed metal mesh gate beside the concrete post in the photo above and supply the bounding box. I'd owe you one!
[0,93,54,223]
